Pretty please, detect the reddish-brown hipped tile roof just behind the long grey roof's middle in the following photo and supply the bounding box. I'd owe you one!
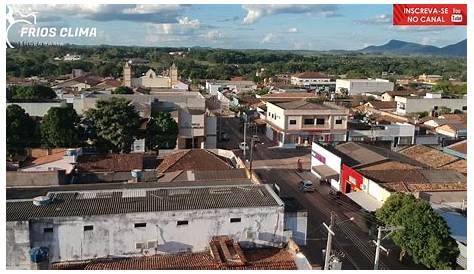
[158,149,234,173]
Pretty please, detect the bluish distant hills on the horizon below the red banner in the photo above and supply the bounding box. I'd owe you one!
[359,39,467,56]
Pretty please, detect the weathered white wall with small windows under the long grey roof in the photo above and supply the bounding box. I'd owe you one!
[7,206,284,267]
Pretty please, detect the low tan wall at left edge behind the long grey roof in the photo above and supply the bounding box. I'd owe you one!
[5,170,68,187]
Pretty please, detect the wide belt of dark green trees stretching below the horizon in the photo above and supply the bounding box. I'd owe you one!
[6,44,467,81]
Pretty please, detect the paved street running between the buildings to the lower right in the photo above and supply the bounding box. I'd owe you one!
[221,116,422,269]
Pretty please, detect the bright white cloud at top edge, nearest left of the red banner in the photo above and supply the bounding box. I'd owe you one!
[242,4,337,24]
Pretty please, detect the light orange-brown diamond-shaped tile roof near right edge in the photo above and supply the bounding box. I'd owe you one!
[400,145,457,168]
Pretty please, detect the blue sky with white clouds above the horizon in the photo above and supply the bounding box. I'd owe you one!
[7,4,467,50]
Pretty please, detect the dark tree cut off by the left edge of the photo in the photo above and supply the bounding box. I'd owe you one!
[6,105,39,160]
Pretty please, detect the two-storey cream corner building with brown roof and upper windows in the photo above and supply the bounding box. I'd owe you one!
[266,100,349,147]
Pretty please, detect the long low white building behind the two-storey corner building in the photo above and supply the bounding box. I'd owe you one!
[336,79,394,95]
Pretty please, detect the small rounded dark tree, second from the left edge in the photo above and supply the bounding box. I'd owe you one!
[41,107,82,148]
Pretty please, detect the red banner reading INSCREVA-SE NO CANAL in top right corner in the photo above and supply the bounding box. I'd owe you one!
[393,4,467,26]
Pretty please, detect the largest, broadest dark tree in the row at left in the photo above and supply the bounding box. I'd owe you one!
[85,97,140,152]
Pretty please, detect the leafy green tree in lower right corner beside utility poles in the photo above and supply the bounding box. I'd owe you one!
[376,193,459,269]
